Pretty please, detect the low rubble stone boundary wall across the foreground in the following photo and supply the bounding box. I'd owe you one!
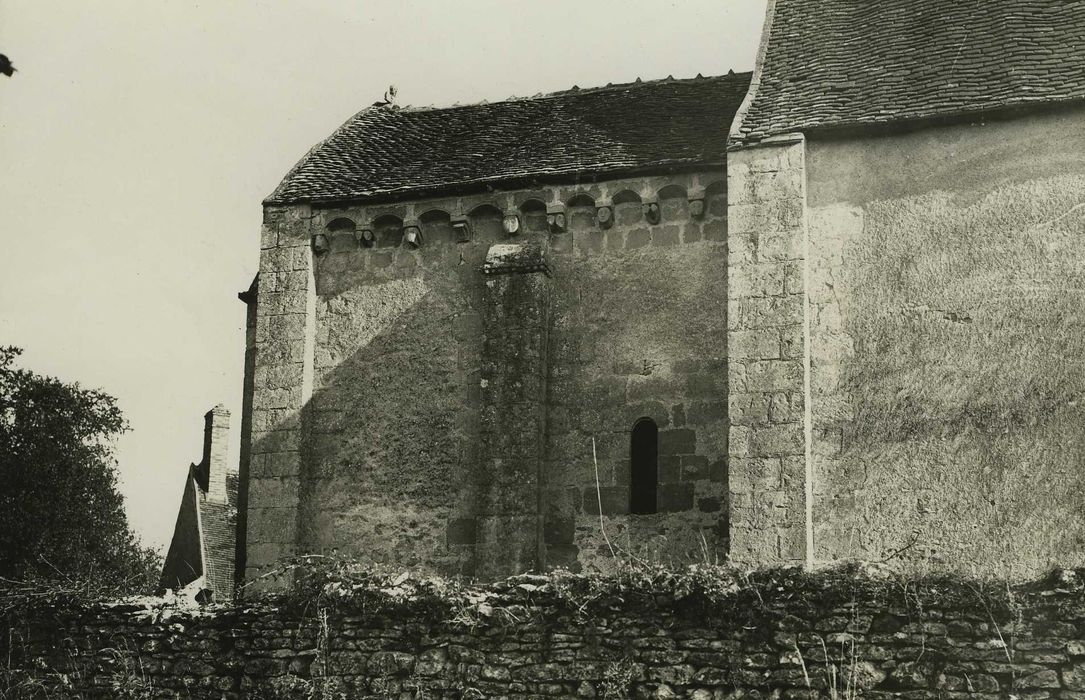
[6,572,1085,700]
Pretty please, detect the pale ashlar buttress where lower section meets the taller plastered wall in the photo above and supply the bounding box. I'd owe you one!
[727,137,808,563]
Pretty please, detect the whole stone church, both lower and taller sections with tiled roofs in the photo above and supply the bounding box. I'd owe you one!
[162,0,1085,594]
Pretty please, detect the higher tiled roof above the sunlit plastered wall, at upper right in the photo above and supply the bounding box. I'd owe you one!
[732,0,1085,142]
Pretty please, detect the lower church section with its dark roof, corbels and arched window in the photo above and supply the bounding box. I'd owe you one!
[236,74,750,577]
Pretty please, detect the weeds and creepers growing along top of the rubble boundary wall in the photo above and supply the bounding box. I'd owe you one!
[248,557,1067,626]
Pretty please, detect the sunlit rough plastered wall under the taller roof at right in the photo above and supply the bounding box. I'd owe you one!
[807,106,1085,577]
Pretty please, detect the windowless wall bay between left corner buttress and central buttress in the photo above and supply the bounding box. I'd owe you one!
[254,211,501,573]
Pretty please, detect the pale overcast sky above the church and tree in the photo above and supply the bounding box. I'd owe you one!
[0,0,764,553]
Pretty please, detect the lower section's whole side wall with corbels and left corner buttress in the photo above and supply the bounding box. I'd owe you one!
[247,173,727,577]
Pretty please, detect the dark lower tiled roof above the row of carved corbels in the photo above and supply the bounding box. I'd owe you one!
[266,73,750,204]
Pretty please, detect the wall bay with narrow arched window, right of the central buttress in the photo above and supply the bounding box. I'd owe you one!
[545,188,729,570]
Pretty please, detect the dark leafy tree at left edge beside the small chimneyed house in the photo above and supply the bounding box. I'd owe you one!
[0,346,161,595]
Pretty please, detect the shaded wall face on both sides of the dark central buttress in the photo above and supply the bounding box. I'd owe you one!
[254,175,728,574]
